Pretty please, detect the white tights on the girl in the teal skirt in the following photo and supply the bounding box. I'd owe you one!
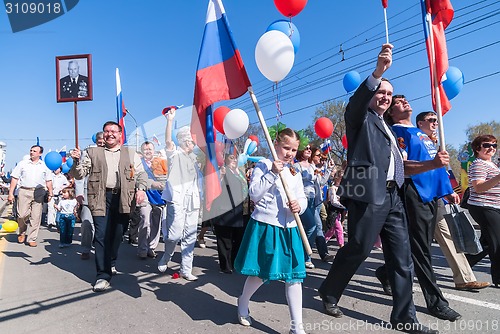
[238,276,305,334]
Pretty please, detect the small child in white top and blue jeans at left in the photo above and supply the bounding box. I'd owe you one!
[54,187,78,248]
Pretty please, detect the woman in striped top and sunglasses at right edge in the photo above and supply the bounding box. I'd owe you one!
[467,135,500,288]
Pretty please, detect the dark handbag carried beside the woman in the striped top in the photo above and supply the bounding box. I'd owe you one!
[443,204,483,255]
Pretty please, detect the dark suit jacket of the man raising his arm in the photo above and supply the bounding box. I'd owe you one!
[338,81,394,205]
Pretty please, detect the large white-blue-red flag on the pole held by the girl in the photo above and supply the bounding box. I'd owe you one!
[191,0,250,210]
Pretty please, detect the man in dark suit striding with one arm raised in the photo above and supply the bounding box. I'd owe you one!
[319,44,438,333]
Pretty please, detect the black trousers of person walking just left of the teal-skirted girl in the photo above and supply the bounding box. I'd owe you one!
[214,225,245,271]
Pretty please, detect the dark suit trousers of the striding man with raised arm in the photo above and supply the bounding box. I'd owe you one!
[319,188,418,323]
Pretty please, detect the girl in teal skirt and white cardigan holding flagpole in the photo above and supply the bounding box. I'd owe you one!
[234,128,307,334]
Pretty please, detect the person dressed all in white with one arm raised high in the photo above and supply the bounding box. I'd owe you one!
[158,108,200,281]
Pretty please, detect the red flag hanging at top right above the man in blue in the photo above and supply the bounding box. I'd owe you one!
[421,0,454,115]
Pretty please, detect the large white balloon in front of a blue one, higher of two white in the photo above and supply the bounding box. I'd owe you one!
[255,30,295,82]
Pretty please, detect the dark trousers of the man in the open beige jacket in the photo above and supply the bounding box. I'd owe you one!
[92,191,130,281]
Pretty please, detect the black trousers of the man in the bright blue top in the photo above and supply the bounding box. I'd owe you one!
[405,181,448,309]
